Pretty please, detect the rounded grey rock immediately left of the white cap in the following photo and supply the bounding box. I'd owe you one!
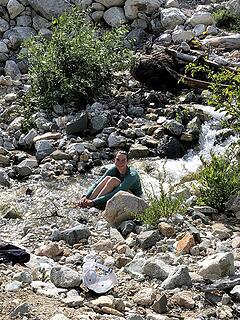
[50,267,81,288]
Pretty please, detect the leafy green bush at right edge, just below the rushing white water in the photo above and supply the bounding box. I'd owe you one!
[196,145,240,212]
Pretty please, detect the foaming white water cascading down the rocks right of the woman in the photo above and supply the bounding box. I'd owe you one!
[134,106,237,194]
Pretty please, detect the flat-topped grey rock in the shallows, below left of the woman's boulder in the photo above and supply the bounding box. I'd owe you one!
[51,224,91,246]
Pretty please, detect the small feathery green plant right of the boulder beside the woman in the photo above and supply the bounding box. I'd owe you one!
[136,169,187,227]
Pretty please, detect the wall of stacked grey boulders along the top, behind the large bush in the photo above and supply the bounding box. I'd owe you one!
[0,0,234,79]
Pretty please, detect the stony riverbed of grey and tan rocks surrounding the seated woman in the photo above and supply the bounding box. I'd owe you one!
[0,0,240,320]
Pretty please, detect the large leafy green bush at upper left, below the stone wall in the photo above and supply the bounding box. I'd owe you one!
[20,7,132,108]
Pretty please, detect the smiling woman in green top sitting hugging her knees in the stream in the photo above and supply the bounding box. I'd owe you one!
[78,151,143,208]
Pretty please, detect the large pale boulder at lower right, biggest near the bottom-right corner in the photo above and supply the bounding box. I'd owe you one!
[199,252,235,280]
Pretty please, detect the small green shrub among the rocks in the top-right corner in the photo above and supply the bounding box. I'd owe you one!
[213,9,240,32]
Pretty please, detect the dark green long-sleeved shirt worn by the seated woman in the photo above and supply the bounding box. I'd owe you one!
[85,165,143,206]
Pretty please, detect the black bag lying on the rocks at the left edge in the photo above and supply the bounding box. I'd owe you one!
[0,244,30,266]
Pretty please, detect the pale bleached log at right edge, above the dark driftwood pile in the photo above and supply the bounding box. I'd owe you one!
[201,33,240,50]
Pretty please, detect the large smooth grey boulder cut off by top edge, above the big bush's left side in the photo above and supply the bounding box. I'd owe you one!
[28,0,71,20]
